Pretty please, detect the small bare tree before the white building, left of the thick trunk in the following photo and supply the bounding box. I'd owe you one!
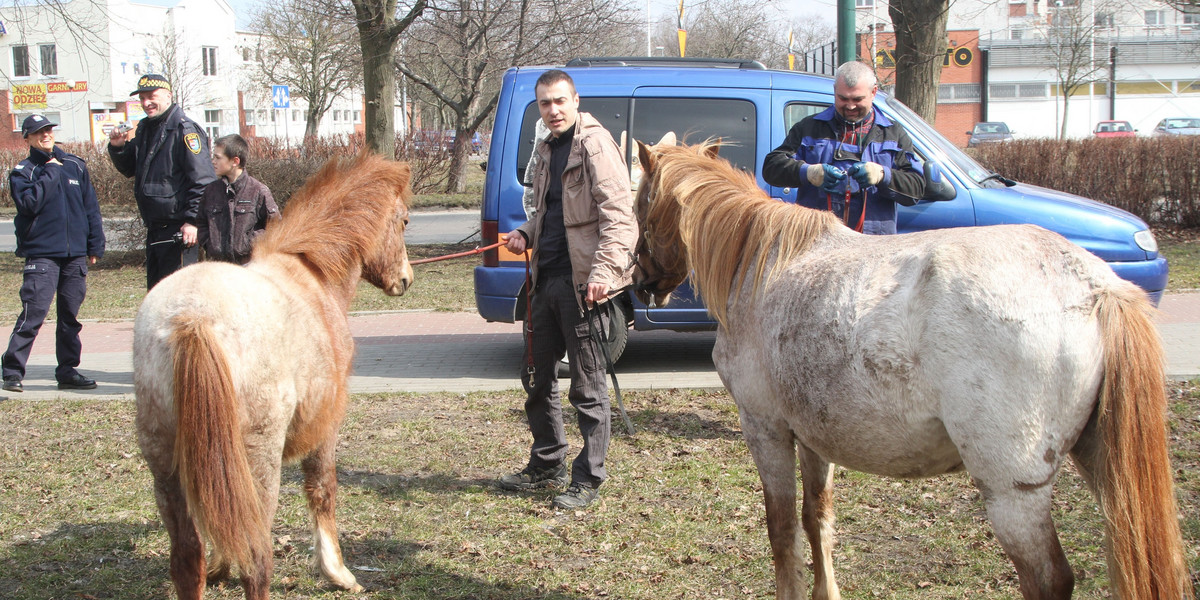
[251,0,362,139]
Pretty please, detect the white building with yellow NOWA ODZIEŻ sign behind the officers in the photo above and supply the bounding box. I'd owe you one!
[0,0,374,145]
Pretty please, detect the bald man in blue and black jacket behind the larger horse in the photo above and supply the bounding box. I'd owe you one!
[762,61,925,234]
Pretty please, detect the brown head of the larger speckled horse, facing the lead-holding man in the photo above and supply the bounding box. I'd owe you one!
[634,132,718,306]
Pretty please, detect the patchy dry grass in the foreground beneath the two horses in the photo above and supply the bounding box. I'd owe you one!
[0,382,1200,600]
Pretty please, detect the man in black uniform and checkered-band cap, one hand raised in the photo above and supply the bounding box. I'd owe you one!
[108,73,217,289]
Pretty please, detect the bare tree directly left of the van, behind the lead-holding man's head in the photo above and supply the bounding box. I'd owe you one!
[395,0,636,192]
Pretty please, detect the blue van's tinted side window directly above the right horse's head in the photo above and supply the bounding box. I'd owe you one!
[634,97,757,173]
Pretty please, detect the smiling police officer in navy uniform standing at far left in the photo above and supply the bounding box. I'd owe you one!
[0,114,104,391]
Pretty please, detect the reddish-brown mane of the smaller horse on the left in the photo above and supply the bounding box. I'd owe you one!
[253,152,413,286]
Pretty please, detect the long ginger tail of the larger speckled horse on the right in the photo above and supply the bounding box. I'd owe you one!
[1094,286,1192,600]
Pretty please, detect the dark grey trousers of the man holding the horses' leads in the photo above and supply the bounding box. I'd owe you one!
[523,275,611,487]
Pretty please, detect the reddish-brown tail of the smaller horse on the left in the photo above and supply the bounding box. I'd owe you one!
[172,317,271,576]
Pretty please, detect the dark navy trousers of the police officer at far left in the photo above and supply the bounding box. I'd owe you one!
[2,257,88,382]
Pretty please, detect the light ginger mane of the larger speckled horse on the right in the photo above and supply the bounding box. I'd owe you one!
[647,142,841,326]
